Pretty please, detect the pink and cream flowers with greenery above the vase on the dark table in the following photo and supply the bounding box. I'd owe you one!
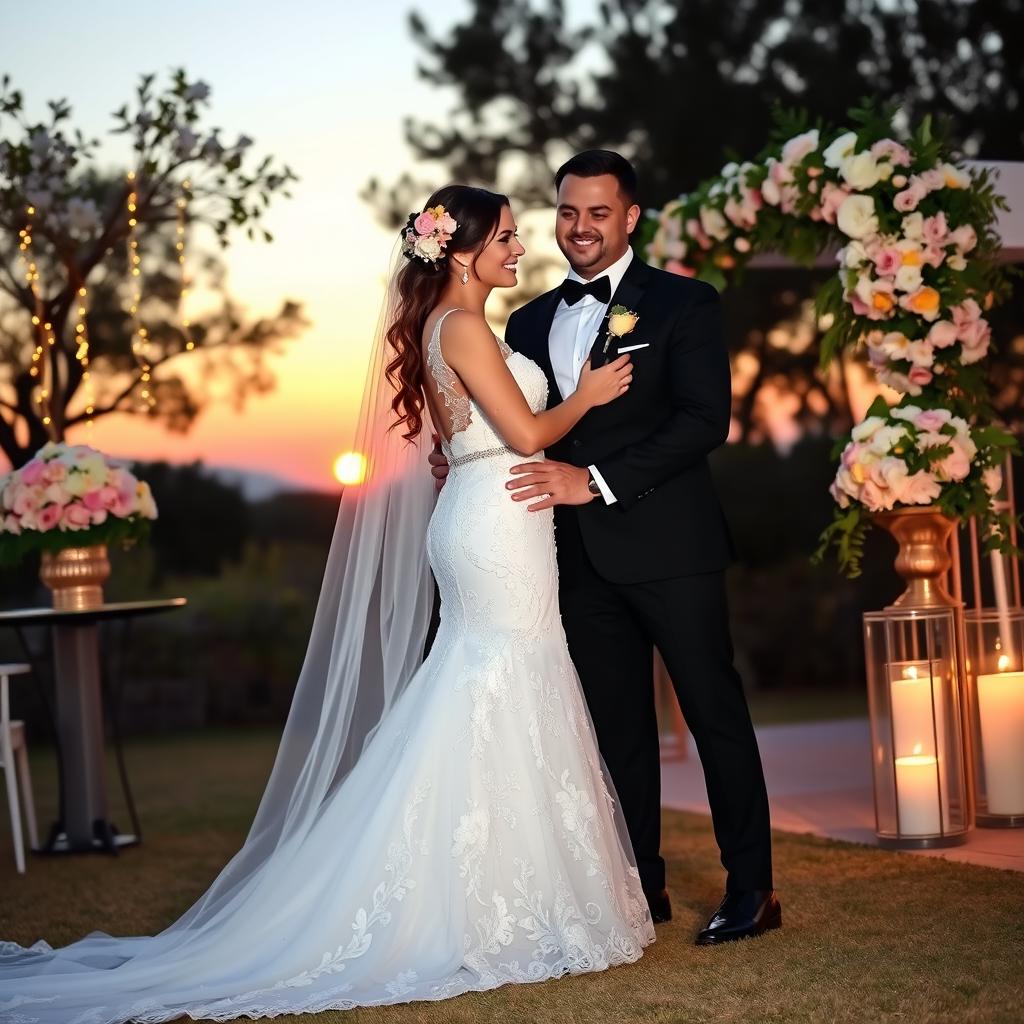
[0,443,157,563]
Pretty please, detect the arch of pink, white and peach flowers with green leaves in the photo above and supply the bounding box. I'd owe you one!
[642,106,1017,575]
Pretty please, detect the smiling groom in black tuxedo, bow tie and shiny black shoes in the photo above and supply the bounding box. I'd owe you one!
[431,150,781,945]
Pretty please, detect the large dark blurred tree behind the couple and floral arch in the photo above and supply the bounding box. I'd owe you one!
[366,0,1024,438]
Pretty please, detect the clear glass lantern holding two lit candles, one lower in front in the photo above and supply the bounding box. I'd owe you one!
[864,605,973,849]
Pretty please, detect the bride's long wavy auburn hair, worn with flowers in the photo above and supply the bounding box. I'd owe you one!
[385,185,509,441]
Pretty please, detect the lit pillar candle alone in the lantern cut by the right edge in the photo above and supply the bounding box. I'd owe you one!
[978,654,1024,814]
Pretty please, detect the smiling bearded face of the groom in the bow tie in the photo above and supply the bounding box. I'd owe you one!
[555,174,640,281]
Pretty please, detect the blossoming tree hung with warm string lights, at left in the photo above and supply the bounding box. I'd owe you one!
[0,70,304,467]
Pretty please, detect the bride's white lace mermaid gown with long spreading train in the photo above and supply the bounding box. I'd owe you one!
[0,325,654,1024]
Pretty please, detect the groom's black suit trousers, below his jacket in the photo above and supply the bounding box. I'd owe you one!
[556,510,772,893]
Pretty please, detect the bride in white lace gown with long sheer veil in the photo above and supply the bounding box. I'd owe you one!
[0,185,654,1024]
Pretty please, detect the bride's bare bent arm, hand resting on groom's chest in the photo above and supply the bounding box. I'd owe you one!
[441,310,633,455]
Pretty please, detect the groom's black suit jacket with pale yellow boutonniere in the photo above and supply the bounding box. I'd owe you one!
[505,256,734,584]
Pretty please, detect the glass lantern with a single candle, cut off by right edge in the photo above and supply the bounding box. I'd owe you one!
[965,607,1024,828]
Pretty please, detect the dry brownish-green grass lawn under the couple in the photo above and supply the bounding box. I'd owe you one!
[0,732,1024,1024]
